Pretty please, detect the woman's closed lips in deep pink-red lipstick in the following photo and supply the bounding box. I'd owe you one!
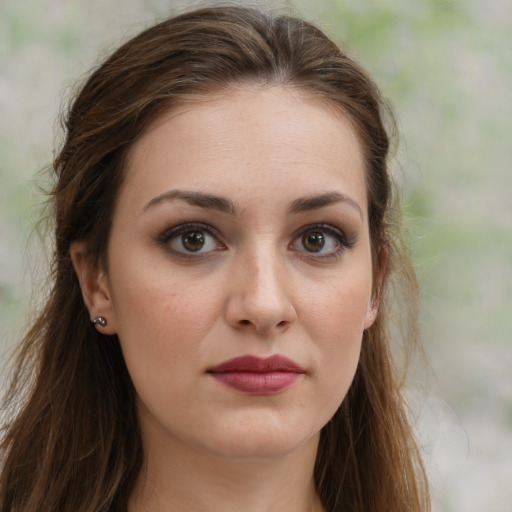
[208,355,306,395]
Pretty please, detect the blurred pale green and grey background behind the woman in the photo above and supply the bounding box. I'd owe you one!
[0,0,512,512]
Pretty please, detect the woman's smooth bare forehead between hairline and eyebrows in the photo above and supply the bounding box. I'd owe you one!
[122,86,366,216]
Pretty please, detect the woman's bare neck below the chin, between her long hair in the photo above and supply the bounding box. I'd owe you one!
[128,437,324,512]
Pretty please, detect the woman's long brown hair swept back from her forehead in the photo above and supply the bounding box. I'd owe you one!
[0,6,430,512]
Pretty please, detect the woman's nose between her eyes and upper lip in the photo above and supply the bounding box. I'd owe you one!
[226,250,297,336]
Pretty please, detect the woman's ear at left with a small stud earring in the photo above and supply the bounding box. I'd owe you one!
[70,242,116,334]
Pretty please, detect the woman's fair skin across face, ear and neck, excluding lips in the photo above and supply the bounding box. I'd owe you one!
[72,85,377,512]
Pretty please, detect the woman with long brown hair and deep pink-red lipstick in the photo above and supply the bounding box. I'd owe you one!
[0,7,429,512]
